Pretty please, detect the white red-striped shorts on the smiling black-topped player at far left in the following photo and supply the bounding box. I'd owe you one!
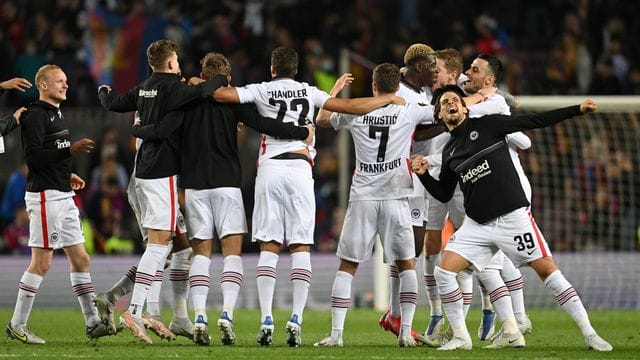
[26,192,84,249]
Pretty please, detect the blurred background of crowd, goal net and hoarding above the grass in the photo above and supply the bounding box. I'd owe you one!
[0,0,640,309]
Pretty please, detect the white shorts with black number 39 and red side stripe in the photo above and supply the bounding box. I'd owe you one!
[445,208,551,271]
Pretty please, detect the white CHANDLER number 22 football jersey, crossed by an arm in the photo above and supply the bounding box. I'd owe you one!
[236,77,330,162]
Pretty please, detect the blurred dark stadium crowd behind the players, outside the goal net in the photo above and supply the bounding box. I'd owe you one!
[0,0,640,253]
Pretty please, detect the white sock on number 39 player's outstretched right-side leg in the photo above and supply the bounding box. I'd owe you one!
[544,270,596,337]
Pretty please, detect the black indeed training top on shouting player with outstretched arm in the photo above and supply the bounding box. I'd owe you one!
[420,105,582,224]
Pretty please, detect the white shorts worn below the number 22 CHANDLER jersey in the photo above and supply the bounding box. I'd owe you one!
[252,159,316,245]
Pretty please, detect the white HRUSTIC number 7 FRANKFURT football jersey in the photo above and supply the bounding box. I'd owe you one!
[331,103,432,201]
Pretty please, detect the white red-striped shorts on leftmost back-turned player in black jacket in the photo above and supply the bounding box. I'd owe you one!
[134,175,184,232]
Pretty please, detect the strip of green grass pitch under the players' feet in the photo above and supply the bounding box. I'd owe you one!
[0,304,640,360]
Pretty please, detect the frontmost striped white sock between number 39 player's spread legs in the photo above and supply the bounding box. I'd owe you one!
[478,269,518,334]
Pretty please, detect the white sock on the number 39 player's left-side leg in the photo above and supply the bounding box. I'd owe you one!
[434,266,471,340]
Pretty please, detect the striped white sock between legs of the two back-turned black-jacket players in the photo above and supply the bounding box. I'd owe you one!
[169,248,193,319]
